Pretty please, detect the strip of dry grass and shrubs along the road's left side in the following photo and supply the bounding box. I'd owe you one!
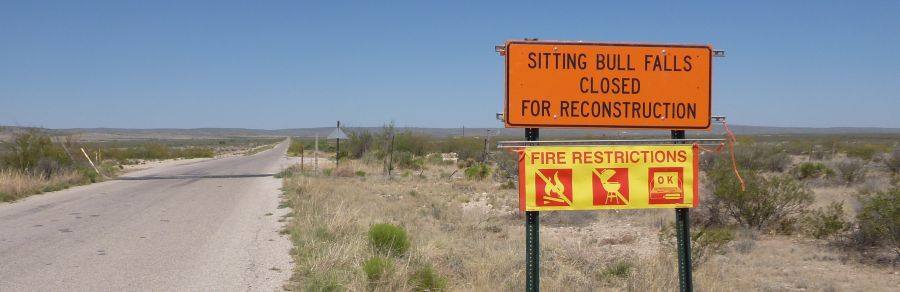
[0,128,280,202]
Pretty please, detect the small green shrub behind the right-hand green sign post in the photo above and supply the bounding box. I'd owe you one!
[658,225,734,269]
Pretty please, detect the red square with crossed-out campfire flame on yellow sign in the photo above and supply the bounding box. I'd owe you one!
[535,169,572,206]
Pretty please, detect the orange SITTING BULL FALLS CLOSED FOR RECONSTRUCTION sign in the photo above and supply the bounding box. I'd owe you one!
[504,41,713,130]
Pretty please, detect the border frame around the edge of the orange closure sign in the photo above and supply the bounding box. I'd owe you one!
[503,40,714,131]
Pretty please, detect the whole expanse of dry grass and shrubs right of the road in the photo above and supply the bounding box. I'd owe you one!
[282,129,900,291]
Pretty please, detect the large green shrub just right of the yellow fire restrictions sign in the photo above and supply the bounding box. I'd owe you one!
[708,165,813,230]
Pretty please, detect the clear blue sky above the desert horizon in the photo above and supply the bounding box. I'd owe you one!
[0,0,900,129]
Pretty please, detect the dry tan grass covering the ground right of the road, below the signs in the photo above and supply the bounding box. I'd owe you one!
[284,161,900,291]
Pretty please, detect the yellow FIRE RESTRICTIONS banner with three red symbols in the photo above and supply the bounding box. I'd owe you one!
[519,145,700,211]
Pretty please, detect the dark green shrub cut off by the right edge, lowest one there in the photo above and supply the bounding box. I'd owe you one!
[856,188,900,256]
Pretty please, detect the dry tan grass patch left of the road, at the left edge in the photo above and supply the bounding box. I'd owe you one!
[0,169,84,202]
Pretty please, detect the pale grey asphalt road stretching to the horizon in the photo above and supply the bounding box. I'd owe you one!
[0,143,292,291]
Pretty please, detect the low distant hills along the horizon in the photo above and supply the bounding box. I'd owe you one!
[0,125,900,140]
